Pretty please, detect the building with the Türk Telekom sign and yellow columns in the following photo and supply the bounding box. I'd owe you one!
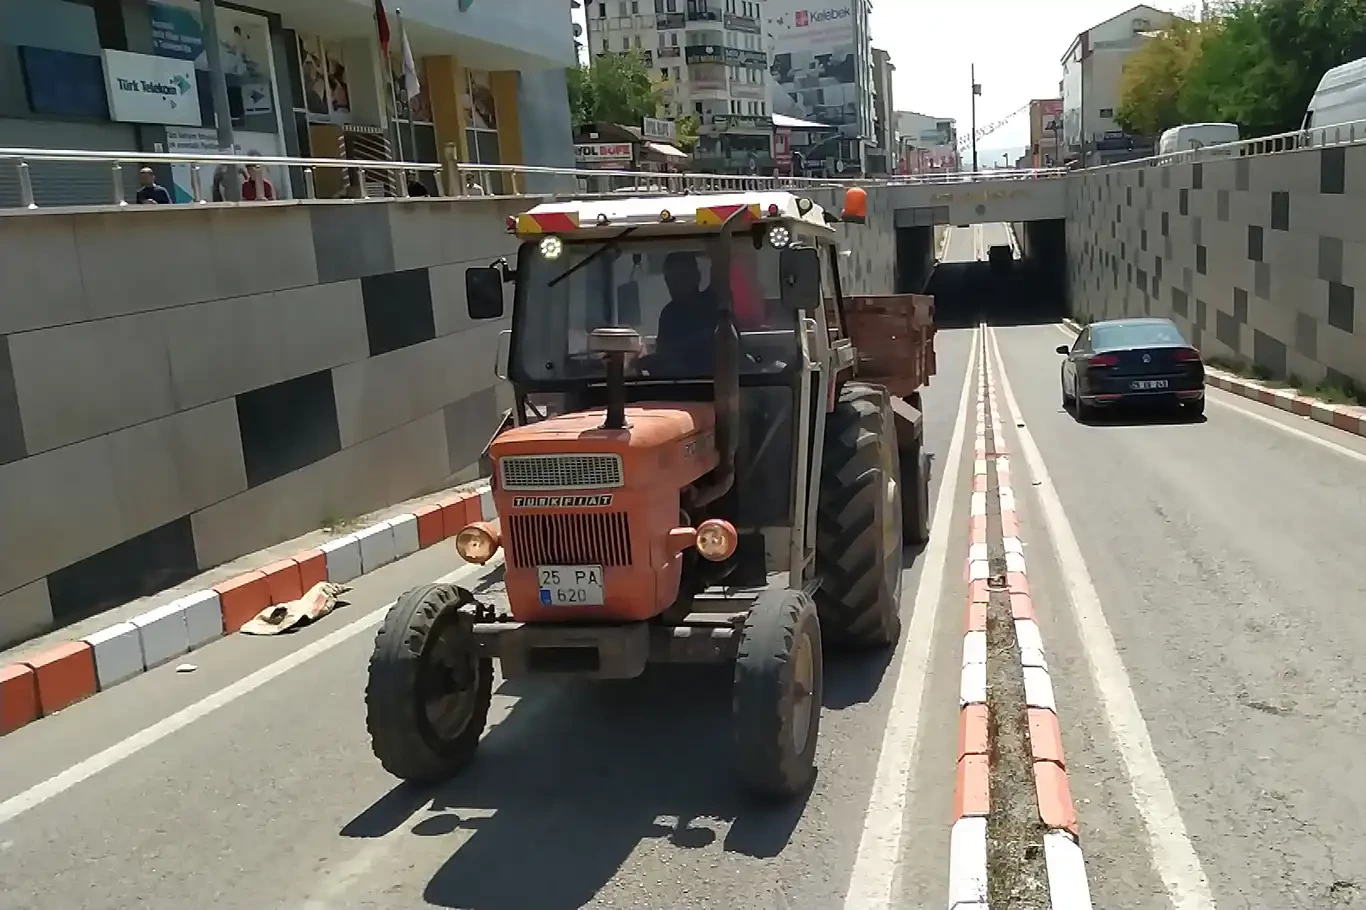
[0,0,574,206]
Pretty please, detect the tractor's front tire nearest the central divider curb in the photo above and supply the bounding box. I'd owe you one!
[731,589,825,799]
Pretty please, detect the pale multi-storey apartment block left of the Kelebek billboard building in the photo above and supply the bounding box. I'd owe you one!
[586,0,773,174]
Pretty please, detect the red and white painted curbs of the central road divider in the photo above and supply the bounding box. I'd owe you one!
[948,335,1091,910]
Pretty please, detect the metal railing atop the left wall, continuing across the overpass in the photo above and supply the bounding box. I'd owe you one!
[0,148,1068,210]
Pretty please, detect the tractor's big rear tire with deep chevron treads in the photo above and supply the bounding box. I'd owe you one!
[816,383,903,648]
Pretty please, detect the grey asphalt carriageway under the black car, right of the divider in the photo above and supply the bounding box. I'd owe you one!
[993,325,1366,910]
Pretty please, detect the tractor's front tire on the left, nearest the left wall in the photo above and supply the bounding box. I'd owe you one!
[365,585,493,783]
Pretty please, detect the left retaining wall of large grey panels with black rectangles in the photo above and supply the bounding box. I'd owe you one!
[0,199,525,644]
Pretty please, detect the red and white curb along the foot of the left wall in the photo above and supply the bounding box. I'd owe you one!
[0,482,496,735]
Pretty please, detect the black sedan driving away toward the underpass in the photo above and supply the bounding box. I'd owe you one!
[1057,318,1205,421]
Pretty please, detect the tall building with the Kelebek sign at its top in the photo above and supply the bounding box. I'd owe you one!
[766,0,877,174]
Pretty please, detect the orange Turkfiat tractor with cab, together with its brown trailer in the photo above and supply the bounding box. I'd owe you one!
[366,189,934,797]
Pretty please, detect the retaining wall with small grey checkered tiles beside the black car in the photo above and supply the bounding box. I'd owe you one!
[1067,145,1366,385]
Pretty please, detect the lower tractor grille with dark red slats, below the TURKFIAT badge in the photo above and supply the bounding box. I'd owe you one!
[507,512,631,568]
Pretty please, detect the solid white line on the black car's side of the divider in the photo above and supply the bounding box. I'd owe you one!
[988,322,1214,910]
